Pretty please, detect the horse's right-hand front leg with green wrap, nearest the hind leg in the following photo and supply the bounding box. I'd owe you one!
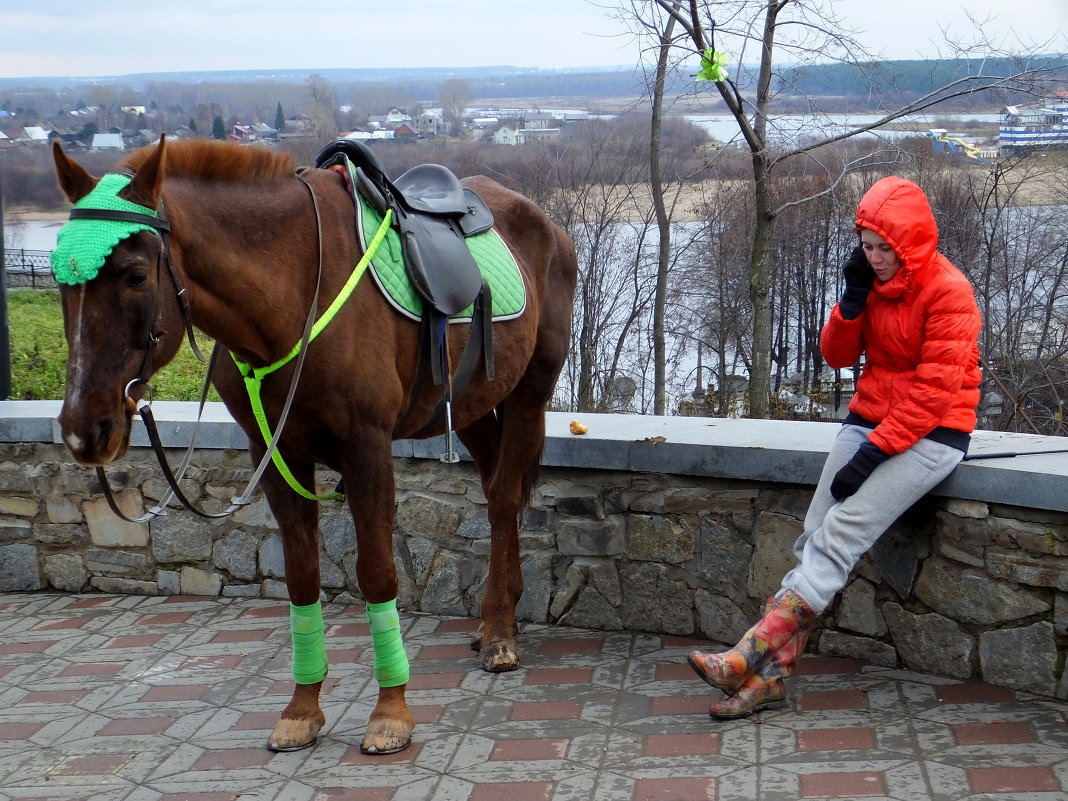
[343,433,415,755]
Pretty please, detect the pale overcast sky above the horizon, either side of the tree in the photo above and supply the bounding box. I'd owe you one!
[0,0,1068,78]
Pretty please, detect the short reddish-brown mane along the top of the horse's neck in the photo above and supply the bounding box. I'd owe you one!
[120,139,297,182]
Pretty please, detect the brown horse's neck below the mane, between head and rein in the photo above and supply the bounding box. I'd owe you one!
[163,179,317,364]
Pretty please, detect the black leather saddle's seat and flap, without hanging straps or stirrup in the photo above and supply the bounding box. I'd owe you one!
[315,139,493,316]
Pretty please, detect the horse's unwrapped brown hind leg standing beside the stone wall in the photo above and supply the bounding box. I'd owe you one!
[457,408,545,673]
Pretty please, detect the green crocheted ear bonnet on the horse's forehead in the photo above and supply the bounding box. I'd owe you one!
[52,173,156,285]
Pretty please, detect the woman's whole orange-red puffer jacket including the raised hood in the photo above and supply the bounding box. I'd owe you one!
[820,177,983,454]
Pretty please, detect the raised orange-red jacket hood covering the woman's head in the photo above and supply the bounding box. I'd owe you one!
[857,175,938,283]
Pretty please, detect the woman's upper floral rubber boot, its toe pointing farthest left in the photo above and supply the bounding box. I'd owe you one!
[688,590,816,695]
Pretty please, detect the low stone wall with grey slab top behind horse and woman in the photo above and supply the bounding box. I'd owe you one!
[0,403,1068,698]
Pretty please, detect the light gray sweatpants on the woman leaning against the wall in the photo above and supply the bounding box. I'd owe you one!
[779,425,964,613]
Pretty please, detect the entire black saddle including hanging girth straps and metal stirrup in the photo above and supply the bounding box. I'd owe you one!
[315,139,493,462]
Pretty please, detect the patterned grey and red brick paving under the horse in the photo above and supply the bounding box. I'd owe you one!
[0,594,1068,801]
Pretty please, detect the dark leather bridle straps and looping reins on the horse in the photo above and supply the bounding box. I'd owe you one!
[94,173,339,523]
